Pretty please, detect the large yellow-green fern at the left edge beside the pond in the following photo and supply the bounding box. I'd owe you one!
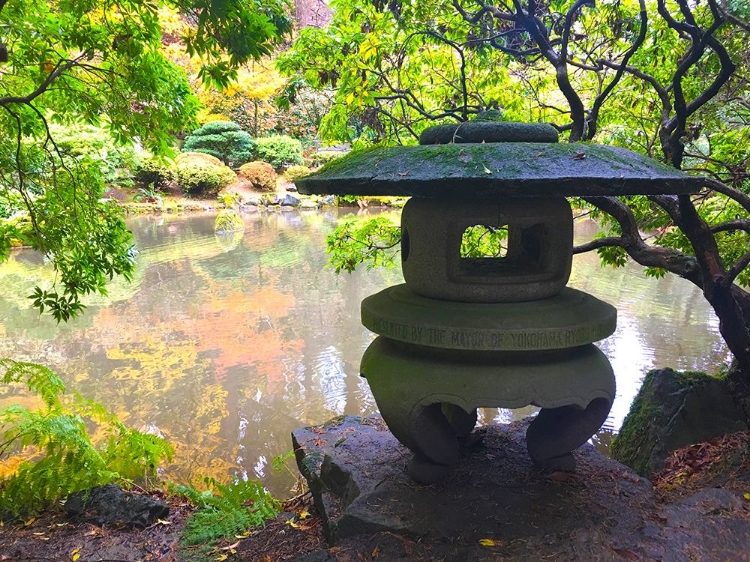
[0,359,172,518]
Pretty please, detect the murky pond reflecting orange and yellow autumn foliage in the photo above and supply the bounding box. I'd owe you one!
[0,210,728,496]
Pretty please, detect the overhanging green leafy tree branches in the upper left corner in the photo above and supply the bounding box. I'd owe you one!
[0,0,290,320]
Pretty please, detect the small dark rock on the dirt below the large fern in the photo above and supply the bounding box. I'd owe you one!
[65,484,169,528]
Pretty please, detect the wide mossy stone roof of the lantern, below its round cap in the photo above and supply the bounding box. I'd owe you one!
[297,142,702,197]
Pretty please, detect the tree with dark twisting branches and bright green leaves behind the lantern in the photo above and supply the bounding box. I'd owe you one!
[282,0,750,380]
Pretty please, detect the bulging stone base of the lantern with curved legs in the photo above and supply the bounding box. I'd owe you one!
[361,336,615,483]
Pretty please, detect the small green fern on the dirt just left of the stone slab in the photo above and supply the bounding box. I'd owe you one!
[177,478,281,545]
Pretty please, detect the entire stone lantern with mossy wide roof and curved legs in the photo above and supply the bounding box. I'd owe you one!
[299,121,699,483]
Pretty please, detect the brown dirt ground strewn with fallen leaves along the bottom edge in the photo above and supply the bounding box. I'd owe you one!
[0,431,750,562]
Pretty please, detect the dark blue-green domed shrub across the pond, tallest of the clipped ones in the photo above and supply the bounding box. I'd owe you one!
[183,121,255,167]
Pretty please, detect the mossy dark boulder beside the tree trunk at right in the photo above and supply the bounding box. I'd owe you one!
[611,369,747,477]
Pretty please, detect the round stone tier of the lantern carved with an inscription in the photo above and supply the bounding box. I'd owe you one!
[362,284,617,351]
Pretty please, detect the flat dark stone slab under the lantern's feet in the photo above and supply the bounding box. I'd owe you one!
[292,416,654,544]
